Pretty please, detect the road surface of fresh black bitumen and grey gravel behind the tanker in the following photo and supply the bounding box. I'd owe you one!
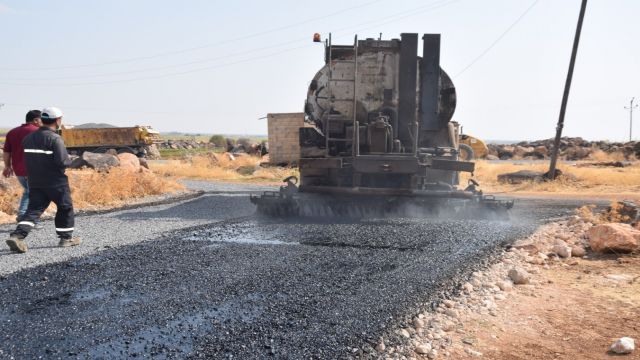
[0,182,600,359]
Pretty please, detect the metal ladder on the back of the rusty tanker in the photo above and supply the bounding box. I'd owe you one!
[325,33,360,158]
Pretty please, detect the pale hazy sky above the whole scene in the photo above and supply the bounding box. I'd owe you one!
[0,0,640,140]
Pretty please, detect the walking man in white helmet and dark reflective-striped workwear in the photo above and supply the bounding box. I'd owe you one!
[7,107,81,253]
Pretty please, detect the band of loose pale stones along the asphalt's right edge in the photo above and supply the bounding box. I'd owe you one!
[376,212,640,359]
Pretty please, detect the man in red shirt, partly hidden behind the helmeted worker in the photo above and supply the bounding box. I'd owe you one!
[2,110,42,221]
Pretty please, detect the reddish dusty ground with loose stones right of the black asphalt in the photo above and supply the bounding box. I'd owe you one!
[386,217,640,359]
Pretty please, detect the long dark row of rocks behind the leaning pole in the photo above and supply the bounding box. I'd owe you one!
[487,137,640,161]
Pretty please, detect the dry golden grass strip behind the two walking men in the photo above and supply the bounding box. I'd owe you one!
[0,168,183,222]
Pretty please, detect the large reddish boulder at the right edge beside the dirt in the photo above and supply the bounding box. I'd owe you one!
[587,223,640,253]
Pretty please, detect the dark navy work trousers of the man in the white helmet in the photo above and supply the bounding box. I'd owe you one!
[11,185,74,239]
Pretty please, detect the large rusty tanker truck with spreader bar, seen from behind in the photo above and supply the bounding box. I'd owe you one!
[251,33,513,217]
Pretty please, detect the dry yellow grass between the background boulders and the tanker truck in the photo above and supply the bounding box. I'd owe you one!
[150,153,298,182]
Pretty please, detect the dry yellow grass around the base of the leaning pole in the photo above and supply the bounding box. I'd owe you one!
[462,161,640,196]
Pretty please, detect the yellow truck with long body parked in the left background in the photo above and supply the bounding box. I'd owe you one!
[60,126,160,157]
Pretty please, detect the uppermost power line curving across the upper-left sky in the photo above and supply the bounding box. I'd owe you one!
[0,0,382,71]
